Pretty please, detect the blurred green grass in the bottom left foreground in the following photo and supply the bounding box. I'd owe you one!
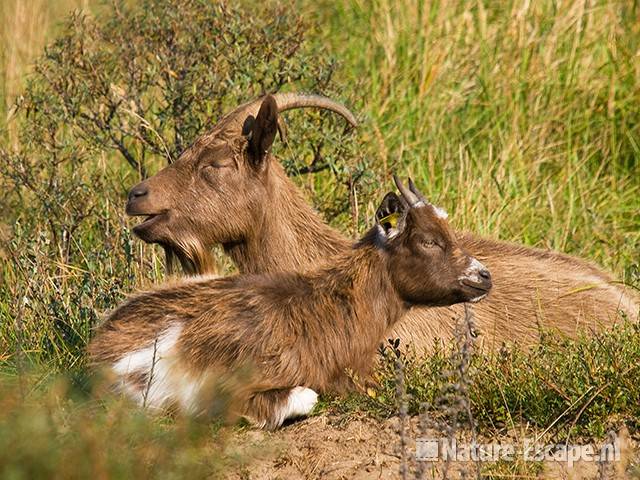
[0,372,242,480]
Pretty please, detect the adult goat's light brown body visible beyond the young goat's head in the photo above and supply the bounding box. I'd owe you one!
[389,234,640,351]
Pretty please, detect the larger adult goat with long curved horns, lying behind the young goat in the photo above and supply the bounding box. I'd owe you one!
[127,94,639,350]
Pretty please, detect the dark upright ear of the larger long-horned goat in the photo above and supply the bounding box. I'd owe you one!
[242,95,278,166]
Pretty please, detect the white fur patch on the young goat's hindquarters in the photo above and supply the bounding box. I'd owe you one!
[113,324,203,413]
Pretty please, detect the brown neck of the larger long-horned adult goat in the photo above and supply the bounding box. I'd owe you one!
[225,161,350,273]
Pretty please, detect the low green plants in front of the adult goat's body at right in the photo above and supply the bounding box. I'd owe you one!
[325,322,640,441]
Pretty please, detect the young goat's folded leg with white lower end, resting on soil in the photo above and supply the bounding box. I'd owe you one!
[245,387,318,430]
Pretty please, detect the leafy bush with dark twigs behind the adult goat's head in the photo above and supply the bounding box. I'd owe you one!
[0,0,360,368]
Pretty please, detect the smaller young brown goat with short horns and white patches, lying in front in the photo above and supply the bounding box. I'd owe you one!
[89,180,491,428]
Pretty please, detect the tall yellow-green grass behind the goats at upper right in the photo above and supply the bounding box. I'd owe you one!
[308,0,640,276]
